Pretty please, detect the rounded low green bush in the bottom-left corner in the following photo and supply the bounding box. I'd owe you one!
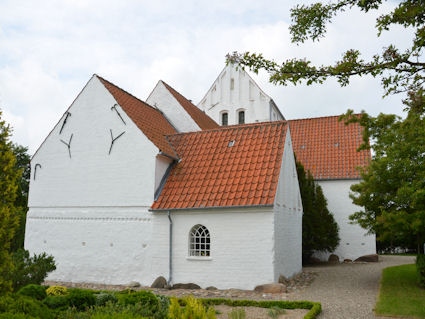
[0,294,53,319]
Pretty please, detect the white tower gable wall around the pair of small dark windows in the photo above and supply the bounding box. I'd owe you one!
[198,65,283,125]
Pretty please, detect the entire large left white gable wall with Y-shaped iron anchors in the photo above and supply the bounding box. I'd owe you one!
[25,77,167,284]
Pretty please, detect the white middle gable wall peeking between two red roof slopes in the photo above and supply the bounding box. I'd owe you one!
[146,81,200,132]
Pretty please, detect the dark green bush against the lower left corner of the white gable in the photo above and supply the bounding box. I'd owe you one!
[7,249,56,291]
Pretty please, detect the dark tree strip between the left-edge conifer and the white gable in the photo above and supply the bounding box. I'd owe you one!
[10,144,31,252]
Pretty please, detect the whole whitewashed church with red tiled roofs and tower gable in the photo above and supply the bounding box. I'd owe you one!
[25,67,375,289]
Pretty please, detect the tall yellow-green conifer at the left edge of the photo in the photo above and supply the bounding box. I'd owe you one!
[0,111,21,294]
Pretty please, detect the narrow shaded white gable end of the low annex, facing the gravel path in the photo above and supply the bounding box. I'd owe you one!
[273,128,303,281]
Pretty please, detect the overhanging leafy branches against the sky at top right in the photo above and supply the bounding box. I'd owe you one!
[227,0,425,95]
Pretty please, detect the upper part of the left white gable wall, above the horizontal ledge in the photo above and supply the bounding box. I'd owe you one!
[28,76,158,208]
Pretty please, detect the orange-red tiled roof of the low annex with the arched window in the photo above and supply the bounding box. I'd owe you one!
[152,122,287,210]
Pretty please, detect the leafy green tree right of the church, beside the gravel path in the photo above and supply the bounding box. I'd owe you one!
[343,90,425,251]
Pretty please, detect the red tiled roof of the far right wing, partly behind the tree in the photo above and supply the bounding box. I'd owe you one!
[288,116,371,180]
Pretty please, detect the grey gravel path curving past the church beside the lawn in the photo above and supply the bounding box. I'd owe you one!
[288,256,415,319]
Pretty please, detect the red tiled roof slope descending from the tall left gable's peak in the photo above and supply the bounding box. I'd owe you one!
[97,76,177,157]
